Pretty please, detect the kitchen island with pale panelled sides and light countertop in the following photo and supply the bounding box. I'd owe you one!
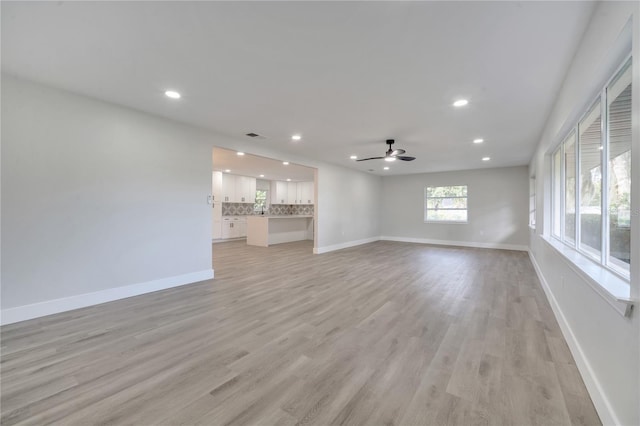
[247,215,313,247]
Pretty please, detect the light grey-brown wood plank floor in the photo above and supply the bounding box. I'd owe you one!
[1,242,600,425]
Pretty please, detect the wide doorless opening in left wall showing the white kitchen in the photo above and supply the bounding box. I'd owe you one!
[211,147,317,270]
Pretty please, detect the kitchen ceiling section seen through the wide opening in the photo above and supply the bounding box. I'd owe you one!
[213,147,315,182]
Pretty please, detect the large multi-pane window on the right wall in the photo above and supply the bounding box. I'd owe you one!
[551,59,631,278]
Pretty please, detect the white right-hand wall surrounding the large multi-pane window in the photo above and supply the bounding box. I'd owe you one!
[530,2,640,425]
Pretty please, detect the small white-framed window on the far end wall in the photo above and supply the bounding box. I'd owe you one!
[424,185,467,223]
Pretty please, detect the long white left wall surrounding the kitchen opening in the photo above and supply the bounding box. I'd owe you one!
[1,75,380,323]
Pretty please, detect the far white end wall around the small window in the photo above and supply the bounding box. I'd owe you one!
[380,166,529,250]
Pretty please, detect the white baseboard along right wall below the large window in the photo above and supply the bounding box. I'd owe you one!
[529,250,621,425]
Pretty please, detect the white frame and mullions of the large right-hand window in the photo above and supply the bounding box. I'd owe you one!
[548,54,633,283]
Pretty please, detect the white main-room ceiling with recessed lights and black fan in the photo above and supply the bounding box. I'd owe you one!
[1,1,594,174]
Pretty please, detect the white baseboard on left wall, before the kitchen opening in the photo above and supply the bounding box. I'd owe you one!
[0,269,214,325]
